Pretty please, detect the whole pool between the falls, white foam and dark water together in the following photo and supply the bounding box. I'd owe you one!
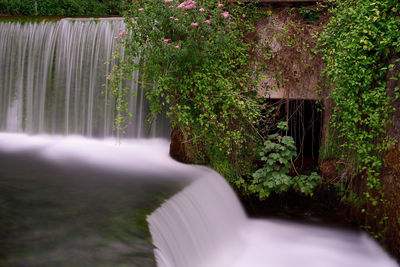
[0,133,191,266]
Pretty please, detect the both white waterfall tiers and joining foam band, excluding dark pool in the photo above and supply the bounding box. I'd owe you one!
[0,19,396,267]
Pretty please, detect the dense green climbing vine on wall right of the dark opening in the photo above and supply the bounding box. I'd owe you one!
[320,0,400,228]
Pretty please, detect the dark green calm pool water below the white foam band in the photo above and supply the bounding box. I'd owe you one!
[0,153,182,266]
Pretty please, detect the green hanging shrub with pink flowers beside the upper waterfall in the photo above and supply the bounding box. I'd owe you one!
[113,0,260,174]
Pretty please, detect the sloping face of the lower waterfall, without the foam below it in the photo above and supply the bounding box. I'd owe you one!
[148,168,246,267]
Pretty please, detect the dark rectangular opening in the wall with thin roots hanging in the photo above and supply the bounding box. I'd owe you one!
[265,99,323,171]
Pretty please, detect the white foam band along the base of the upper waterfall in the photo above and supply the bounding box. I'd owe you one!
[0,133,190,179]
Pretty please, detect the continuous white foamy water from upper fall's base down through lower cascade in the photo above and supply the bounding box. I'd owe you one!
[0,133,398,267]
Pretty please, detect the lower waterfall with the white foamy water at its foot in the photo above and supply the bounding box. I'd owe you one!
[147,168,398,267]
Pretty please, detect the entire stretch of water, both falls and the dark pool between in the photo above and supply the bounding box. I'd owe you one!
[0,19,397,267]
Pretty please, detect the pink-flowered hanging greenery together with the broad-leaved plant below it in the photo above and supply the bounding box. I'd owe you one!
[111,0,320,198]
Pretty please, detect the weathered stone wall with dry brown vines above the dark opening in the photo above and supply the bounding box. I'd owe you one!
[254,6,326,100]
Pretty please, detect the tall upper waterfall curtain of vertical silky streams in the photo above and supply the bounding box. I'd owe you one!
[0,18,168,137]
